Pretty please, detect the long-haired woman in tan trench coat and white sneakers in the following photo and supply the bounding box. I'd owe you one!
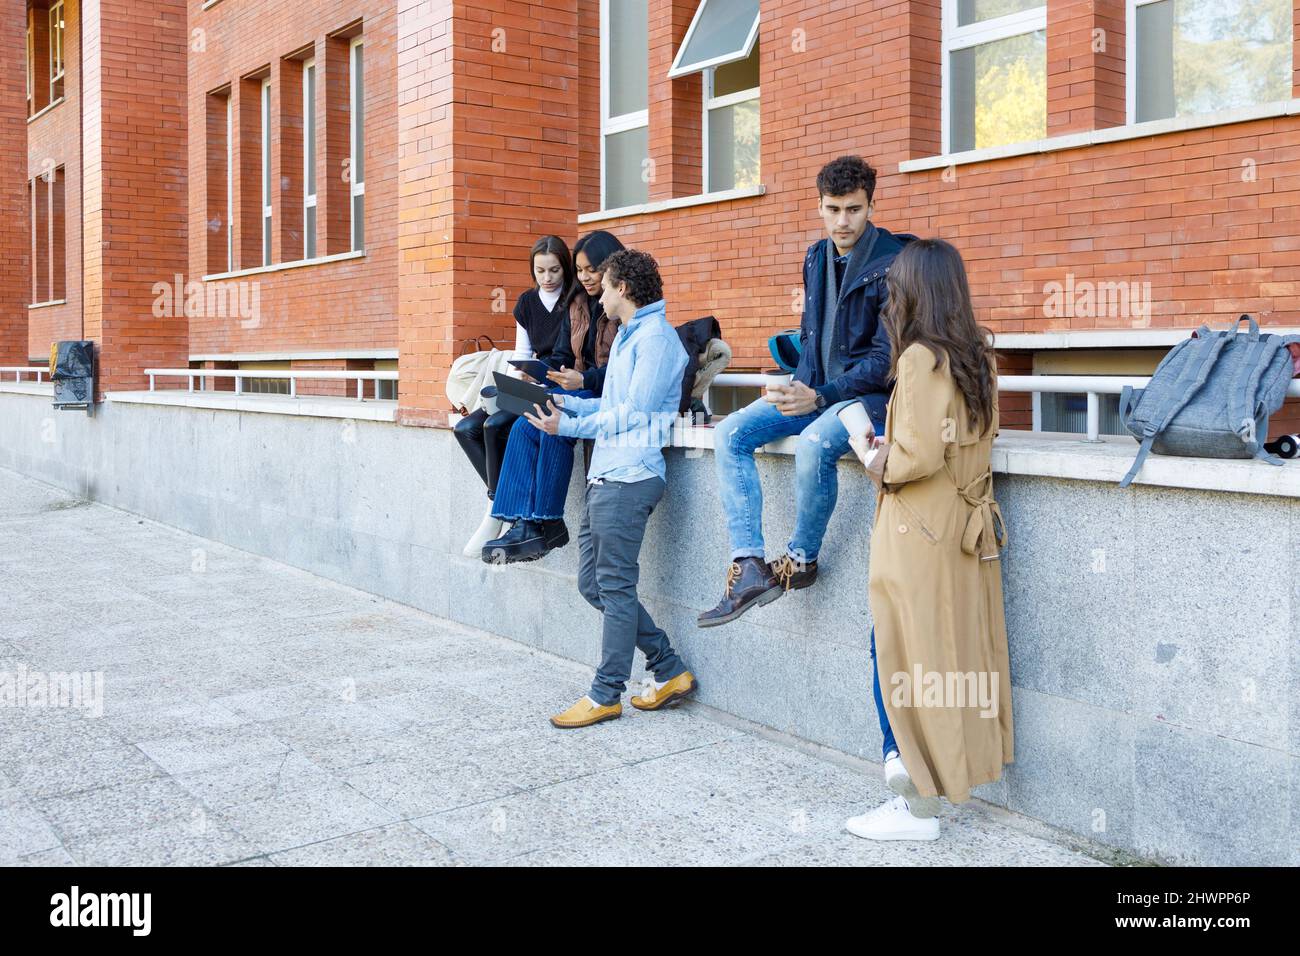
[848,239,1013,839]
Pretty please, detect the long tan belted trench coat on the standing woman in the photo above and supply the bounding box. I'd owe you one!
[870,345,1013,803]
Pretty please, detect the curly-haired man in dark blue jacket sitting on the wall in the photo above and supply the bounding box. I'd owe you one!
[699,156,914,627]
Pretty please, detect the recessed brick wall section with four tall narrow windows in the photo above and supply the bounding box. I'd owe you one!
[186,0,399,354]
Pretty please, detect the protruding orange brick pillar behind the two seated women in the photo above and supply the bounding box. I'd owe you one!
[395,0,581,424]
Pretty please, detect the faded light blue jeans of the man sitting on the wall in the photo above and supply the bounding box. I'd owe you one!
[714,398,849,561]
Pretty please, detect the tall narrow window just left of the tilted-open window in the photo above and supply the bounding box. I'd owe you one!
[601,0,650,209]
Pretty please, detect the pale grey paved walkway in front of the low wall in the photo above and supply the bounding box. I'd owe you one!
[0,470,1096,866]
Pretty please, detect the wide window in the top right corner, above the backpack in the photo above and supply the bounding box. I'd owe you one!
[1127,0,1294,122]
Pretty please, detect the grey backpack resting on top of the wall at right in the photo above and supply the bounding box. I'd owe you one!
[1119,315,1300,488]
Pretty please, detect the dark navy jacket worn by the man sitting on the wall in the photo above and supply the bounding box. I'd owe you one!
[794,225,917,433]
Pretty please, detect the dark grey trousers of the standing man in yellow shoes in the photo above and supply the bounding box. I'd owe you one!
[577,477,686,706]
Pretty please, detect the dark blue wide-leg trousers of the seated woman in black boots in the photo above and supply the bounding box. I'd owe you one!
[491,389,590,522]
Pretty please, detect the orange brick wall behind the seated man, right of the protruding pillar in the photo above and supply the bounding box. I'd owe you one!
[572,0,1300,367]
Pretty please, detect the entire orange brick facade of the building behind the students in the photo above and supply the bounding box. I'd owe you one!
[0,0,1300,421]
